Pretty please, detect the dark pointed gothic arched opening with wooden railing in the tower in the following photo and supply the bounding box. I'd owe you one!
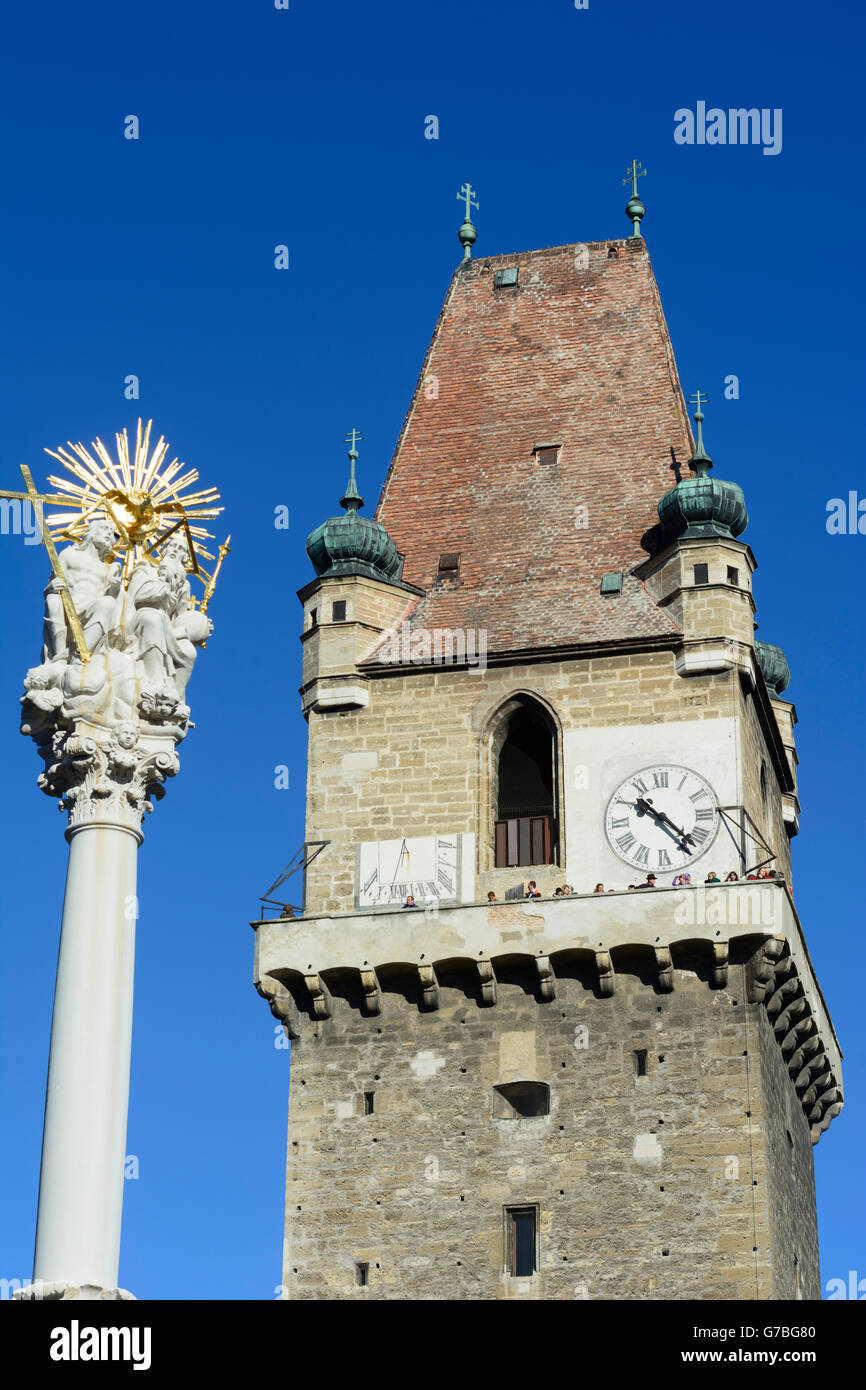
[493,696,557,869]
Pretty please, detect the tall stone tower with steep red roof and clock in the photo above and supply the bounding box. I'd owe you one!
[256,236,842,1300]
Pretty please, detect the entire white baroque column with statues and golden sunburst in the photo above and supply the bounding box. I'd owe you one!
[8,421,228,1298]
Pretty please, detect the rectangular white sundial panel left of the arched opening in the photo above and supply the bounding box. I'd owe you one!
[357,834,463,908]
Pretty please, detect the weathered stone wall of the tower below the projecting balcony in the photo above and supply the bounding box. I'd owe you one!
[284,956,817,1300]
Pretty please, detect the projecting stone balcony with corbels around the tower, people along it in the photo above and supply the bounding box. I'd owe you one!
[252,880,842,1140]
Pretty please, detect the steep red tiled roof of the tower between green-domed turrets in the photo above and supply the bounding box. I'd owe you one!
[373,239,691,660]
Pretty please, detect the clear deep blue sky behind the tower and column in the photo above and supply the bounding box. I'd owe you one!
[0,0,866,1298]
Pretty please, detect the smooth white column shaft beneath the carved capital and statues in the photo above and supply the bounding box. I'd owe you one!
[33,821,143,1297]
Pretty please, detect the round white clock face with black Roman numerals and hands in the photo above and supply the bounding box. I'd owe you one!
[605,763,719,873]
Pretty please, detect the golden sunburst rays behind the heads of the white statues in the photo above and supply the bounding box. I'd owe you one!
[46,420,224,585]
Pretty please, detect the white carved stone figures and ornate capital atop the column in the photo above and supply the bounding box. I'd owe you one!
[21,520,213,820]
